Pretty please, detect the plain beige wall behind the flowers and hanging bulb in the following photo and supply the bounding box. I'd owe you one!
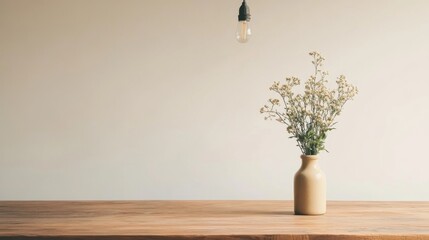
[0,0,429,200]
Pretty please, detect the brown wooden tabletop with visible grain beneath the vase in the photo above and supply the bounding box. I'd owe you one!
[0,201,429,240]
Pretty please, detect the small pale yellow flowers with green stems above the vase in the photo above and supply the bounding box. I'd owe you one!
[260,52,358,155]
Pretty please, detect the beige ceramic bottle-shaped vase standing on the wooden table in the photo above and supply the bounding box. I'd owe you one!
[294,155,326,215]
